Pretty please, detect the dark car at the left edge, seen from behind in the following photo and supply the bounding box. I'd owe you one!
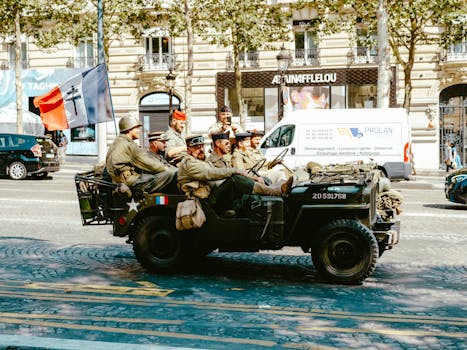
[0,133,60,180]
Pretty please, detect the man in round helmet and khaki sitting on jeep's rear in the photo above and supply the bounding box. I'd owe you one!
[106,116,178,193]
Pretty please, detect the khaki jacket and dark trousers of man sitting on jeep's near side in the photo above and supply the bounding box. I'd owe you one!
[178,155,255,211]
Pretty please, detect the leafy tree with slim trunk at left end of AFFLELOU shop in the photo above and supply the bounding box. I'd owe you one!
[198,0,291,128]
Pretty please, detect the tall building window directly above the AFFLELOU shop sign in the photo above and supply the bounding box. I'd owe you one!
[292,21,319,66]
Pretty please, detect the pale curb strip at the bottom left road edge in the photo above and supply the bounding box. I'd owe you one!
[0,334,207,350]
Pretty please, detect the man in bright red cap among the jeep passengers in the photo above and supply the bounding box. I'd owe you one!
[165,110,186,164]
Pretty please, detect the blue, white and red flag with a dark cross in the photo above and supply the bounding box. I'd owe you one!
[34,64,114,131]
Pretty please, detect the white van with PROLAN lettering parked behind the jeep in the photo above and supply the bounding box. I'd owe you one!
[260,108,411,179]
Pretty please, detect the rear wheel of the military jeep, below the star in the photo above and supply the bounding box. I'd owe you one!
[133,216,183,271]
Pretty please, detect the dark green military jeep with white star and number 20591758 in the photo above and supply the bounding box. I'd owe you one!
[75,159,400,284]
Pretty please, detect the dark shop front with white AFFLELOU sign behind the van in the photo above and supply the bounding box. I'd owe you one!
[217,67,397,131]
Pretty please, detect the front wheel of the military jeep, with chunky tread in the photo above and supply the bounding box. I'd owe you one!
[311,219,379,284]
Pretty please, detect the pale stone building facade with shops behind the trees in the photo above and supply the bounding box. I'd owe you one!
[0,5,467,169]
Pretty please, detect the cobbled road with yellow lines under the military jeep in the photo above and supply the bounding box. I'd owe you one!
[0,164,467,349]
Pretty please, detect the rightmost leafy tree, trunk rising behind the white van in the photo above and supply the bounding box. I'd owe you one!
[302,0,465,111]
